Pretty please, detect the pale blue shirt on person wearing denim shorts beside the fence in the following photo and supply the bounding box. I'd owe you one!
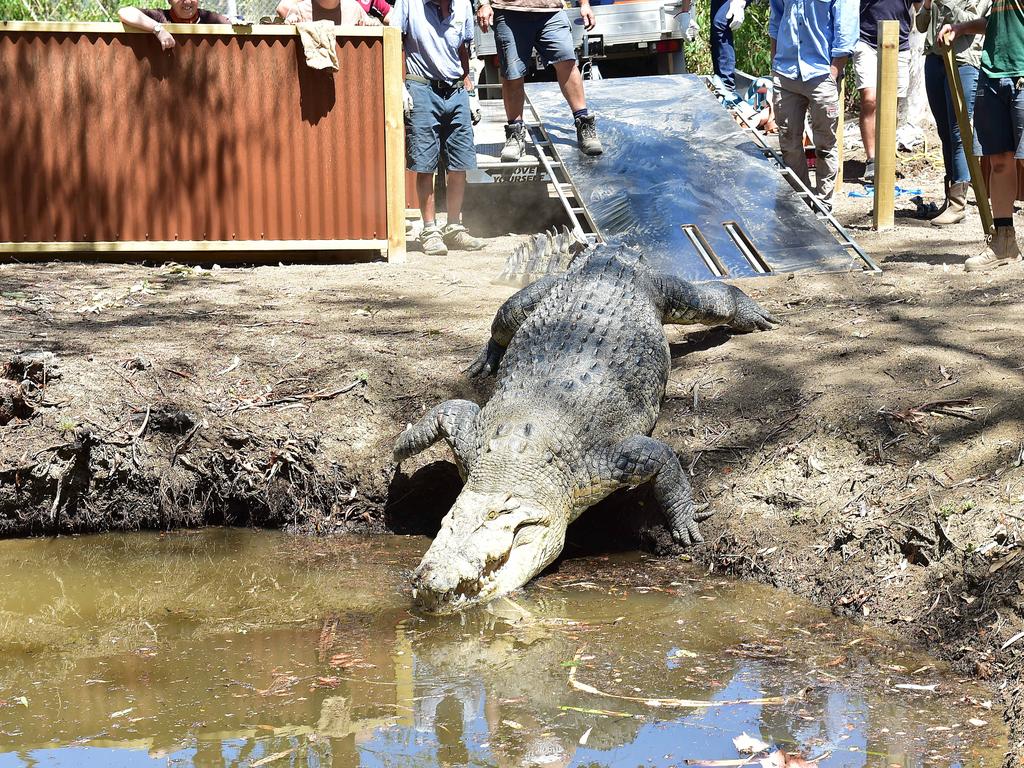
[391,0,473,80]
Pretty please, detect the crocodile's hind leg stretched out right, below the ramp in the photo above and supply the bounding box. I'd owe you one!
[660,278,778,332]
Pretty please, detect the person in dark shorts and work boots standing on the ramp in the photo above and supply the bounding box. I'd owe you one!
[476,0,604,163]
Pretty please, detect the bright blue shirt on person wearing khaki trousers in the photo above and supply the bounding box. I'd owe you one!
[768,0,860,81]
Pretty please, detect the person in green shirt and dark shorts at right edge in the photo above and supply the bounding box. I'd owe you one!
[939,0,1024,272]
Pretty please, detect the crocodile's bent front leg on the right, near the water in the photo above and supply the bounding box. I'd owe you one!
[598,435,711,547]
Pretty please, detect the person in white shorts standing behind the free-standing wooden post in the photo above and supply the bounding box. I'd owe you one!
[853,0,920,181]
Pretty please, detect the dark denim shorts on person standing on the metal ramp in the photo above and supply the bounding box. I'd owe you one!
[495,9,575,80]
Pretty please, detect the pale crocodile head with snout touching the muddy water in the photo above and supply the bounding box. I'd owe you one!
[413,488,568,613]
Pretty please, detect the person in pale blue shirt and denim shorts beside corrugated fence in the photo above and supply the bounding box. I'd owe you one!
[391,0,483,255]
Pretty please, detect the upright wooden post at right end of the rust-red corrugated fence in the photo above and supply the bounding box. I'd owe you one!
[383,27,406,264]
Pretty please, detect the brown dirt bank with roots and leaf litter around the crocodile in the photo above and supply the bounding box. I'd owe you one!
[0,140,1024,765]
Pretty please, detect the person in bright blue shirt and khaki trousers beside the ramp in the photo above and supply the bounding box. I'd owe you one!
[768,0,860,208]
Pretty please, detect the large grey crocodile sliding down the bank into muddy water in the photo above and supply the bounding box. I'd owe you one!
[394,240,775,612]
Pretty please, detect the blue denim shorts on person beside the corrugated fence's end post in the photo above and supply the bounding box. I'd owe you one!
[406,80,476,173]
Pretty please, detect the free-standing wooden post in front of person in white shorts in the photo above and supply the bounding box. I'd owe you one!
[871,19,899,229]
